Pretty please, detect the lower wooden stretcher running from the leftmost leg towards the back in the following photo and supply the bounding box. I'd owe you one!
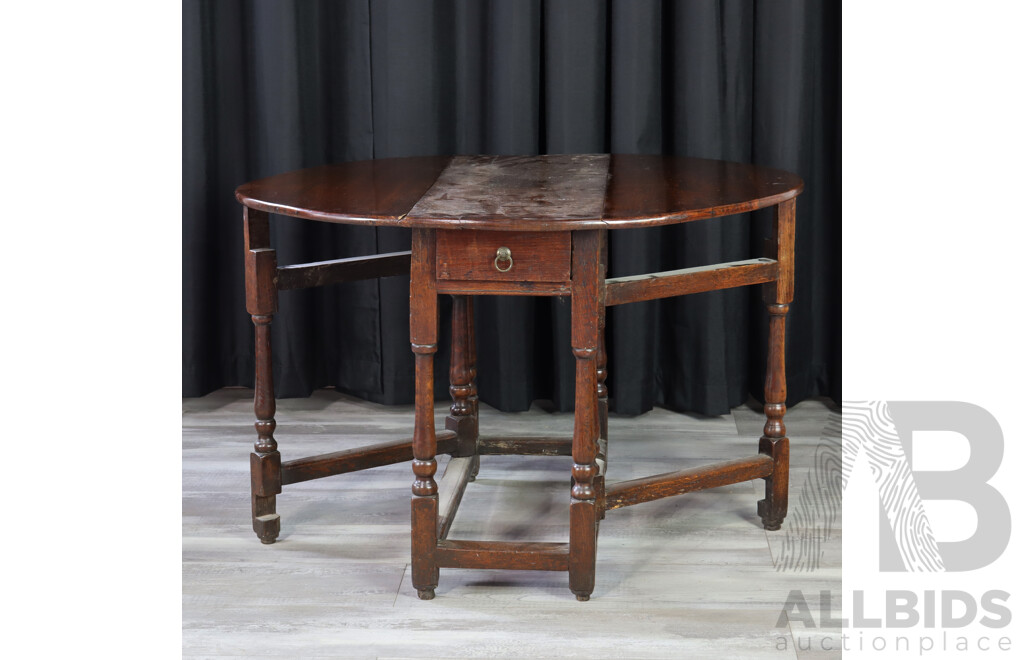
[281,431,458,485]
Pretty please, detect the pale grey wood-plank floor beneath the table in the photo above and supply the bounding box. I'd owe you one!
[182,389,842,659]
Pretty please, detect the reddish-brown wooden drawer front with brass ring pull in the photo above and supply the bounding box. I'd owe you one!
[437,229,572,282]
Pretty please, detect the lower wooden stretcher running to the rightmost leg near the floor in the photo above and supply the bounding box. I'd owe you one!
[604,454,774,511]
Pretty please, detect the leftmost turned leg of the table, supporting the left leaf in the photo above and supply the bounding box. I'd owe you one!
[243,209,281,543]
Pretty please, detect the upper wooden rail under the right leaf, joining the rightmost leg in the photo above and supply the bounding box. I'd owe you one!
[604,257,778,307]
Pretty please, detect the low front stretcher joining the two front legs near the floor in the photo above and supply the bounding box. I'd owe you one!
[434,540,569,571]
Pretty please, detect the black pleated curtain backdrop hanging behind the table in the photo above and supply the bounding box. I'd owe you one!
[182,0,841,414]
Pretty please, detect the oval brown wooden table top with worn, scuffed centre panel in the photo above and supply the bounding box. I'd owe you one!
[234,153,804,231]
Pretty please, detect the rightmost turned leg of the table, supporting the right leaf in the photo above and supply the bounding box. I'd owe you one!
[758,200,796,531]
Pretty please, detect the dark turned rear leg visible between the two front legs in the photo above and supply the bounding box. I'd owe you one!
[444,296,480,481]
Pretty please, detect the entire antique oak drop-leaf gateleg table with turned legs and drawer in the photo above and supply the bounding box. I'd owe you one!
[236,155,803,601]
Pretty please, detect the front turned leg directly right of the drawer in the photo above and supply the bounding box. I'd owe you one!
[568,230,601,601]
